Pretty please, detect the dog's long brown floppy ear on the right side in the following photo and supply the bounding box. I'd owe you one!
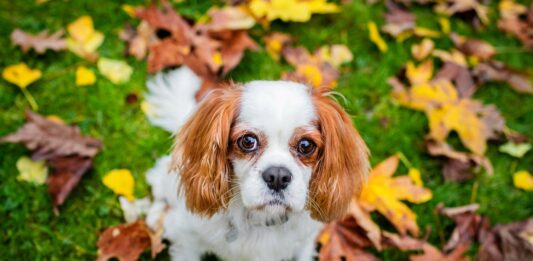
[308,91,369,222]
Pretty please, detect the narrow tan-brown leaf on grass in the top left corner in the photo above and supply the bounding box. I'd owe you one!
[11,28,67,54]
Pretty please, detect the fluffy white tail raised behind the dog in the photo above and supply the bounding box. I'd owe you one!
[145,66,201,133]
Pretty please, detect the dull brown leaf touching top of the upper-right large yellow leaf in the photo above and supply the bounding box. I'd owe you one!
[435,62,478,98]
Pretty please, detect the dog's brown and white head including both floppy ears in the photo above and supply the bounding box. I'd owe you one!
[174,81,368,222]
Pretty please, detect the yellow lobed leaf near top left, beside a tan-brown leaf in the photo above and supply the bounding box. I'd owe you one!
[67,16,104,60]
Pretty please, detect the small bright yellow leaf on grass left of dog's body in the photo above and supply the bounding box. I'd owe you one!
[102,169,135,201]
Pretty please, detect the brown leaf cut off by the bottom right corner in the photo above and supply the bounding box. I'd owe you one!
[477,218,533,261]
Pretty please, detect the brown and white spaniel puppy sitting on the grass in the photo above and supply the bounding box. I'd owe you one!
[146,67,369,261]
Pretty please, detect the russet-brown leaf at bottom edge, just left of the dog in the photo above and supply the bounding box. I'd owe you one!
[96,220,164,261]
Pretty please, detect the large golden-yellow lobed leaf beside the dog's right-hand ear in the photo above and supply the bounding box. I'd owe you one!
[358,155,432,236]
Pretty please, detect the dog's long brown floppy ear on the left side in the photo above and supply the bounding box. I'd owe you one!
[172,86,240,216]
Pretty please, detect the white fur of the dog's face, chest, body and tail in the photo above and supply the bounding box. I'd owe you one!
[147,69,322,261]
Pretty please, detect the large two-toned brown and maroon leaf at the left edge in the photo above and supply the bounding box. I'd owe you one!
[0,111,102,212]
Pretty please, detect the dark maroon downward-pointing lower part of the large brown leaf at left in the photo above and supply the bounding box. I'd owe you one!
[46,156,92,210]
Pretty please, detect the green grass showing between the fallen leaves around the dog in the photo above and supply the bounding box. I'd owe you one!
[0,0,533,260]
